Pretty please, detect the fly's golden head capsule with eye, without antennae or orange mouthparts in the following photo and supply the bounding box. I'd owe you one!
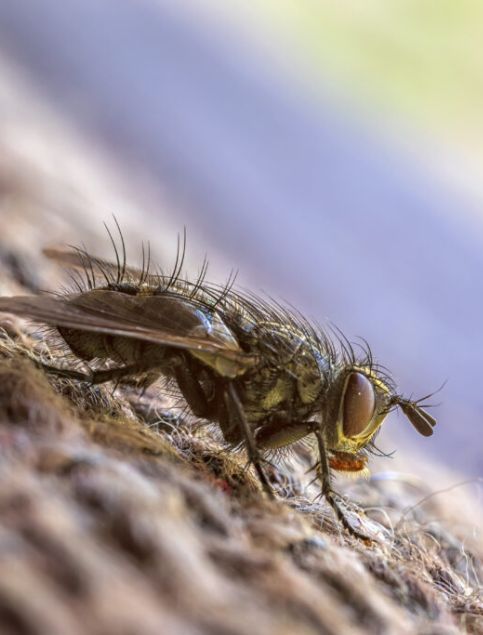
[322,365,391,452]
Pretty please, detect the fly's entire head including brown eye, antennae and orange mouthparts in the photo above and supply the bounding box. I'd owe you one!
[323,364,436,472]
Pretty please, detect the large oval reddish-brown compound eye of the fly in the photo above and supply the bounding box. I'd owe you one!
[342,373,376,437]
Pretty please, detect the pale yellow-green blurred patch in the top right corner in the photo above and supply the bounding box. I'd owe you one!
[258,0,483,145]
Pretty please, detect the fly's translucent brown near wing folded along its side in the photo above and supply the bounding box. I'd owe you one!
[0,290,257,376]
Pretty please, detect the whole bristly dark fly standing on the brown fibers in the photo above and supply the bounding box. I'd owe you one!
[0,227,436,537]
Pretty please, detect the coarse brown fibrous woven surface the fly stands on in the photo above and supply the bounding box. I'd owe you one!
[0,129,483,635]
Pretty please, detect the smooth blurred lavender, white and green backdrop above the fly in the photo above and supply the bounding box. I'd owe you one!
[0,0,483,482]
